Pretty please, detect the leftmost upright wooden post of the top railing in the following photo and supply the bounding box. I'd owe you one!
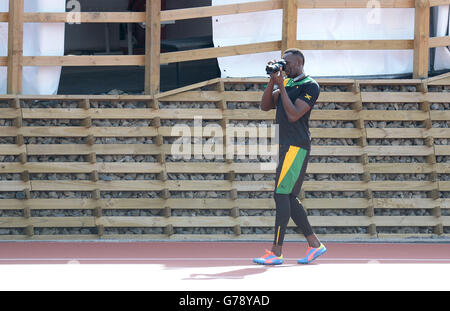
[7,0,24,94]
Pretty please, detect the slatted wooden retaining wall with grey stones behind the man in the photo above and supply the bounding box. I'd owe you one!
[0,74,450,240]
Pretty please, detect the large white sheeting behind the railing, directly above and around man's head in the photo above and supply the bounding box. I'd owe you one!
[212,0,414,77]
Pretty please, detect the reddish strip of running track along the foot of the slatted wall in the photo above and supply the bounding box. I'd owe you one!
[0,241,450,267]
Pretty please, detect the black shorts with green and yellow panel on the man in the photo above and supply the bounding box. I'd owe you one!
[275,145,309,195]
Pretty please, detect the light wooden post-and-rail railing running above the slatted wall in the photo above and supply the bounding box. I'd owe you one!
[0,0,450,95]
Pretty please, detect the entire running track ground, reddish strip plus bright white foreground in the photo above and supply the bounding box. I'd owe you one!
[0,241,450,292]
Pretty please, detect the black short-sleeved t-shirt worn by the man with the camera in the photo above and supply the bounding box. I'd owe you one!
[276,76,320,150]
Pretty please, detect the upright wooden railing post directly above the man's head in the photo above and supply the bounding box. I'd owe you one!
[281,0,298,53]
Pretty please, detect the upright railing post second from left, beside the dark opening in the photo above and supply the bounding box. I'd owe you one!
[145,0,161,95]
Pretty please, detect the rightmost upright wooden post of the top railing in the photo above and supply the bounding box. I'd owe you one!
[413,0,430,79]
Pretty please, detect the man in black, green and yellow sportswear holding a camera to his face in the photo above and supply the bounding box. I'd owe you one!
[253,49,326,265]
